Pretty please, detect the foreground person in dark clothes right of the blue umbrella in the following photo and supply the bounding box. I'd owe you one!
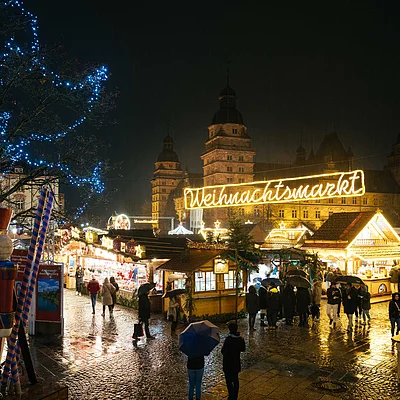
[221,322,246,400]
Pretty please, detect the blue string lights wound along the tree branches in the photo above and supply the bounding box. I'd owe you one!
[0,0,108,214]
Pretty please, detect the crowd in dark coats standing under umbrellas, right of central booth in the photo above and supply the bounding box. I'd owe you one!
[246,280,376,332]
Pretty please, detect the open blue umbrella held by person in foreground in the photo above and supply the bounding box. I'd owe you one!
[179,320,220,357]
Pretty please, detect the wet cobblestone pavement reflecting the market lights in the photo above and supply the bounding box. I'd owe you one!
[2,290,400,400]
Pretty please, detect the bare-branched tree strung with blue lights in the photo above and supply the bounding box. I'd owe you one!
[0,0,113,222]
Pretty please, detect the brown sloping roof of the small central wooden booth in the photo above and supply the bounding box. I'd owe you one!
[157,249,222,272]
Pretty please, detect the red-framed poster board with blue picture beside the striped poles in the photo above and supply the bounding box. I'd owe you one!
[36,264,63,322]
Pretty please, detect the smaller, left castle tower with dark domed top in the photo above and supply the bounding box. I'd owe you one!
[151,135,183,233]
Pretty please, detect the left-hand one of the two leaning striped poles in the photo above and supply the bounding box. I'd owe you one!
[2,187,47,389]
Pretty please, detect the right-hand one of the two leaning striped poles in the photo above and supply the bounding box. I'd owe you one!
[11,192,54,384]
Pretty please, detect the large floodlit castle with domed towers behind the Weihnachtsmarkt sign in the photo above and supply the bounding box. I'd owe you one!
[152,80,400,232]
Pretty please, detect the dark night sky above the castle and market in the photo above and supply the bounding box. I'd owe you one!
[25,0,400,219]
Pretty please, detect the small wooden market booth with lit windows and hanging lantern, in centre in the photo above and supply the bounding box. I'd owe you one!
[157,249,247,316]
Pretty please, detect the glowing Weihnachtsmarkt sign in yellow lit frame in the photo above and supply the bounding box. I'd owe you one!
[184,170,365,210]
